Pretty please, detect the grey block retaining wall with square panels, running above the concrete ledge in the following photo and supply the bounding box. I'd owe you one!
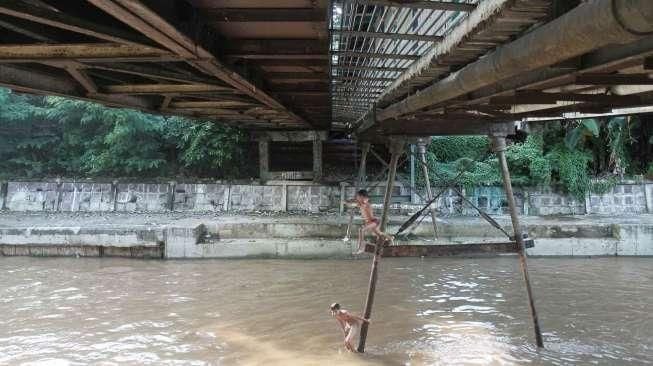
[0,180,653,216]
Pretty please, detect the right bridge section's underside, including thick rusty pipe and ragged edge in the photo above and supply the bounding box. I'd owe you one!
[346,0,653,139]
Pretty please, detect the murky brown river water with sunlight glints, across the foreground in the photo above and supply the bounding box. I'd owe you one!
[0,257,653,365]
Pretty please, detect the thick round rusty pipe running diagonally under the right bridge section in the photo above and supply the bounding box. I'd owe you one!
[376,0,653,120]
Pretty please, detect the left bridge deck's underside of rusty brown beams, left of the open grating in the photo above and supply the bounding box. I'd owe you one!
[0,0,331,130]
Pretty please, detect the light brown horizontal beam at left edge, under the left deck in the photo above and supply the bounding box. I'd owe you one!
[0,43,170,62]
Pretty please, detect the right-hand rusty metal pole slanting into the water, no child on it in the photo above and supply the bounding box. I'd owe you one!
[492,135,544,347]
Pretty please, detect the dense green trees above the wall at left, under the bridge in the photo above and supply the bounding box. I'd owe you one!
[0,88,246,177]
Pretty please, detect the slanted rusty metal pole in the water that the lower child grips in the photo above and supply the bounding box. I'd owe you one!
[358,139,404,353]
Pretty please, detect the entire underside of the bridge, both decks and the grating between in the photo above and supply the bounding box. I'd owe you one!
[0,0,653,140]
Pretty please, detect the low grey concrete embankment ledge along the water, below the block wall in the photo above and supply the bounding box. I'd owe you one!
[0,213,653,259]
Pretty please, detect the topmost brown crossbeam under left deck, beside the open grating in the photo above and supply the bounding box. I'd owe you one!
[202,8,327,23]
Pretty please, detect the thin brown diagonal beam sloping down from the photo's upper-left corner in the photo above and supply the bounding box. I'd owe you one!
[0,0,149,45]
